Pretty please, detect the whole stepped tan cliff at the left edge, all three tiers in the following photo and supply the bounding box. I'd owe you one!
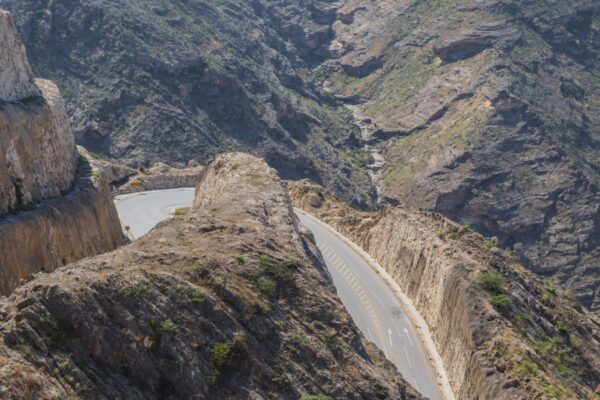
[0,11,124,295]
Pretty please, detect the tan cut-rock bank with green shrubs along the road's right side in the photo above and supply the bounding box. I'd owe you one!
[288,181,600,399]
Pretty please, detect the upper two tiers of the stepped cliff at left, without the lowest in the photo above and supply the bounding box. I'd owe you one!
[0,11,79,215]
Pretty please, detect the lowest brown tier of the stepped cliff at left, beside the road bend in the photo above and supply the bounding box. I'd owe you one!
[0,152,125,295]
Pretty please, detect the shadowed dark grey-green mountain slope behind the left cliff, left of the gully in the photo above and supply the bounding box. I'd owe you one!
[0,0,374,204]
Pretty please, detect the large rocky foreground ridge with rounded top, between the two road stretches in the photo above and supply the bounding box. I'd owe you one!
[0,154,420,400]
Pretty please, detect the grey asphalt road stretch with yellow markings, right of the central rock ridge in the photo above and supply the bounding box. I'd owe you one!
[298,214,442,400]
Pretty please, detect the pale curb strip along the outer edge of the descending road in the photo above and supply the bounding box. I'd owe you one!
[294,207,455,400]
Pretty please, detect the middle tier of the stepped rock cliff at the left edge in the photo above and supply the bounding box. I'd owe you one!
[0,80,79,215]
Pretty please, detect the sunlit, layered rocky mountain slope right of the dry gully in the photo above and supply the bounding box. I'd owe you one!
[323,0,600,310]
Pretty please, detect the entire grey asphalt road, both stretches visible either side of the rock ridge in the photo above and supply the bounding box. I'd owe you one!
[115,188,442,400]
